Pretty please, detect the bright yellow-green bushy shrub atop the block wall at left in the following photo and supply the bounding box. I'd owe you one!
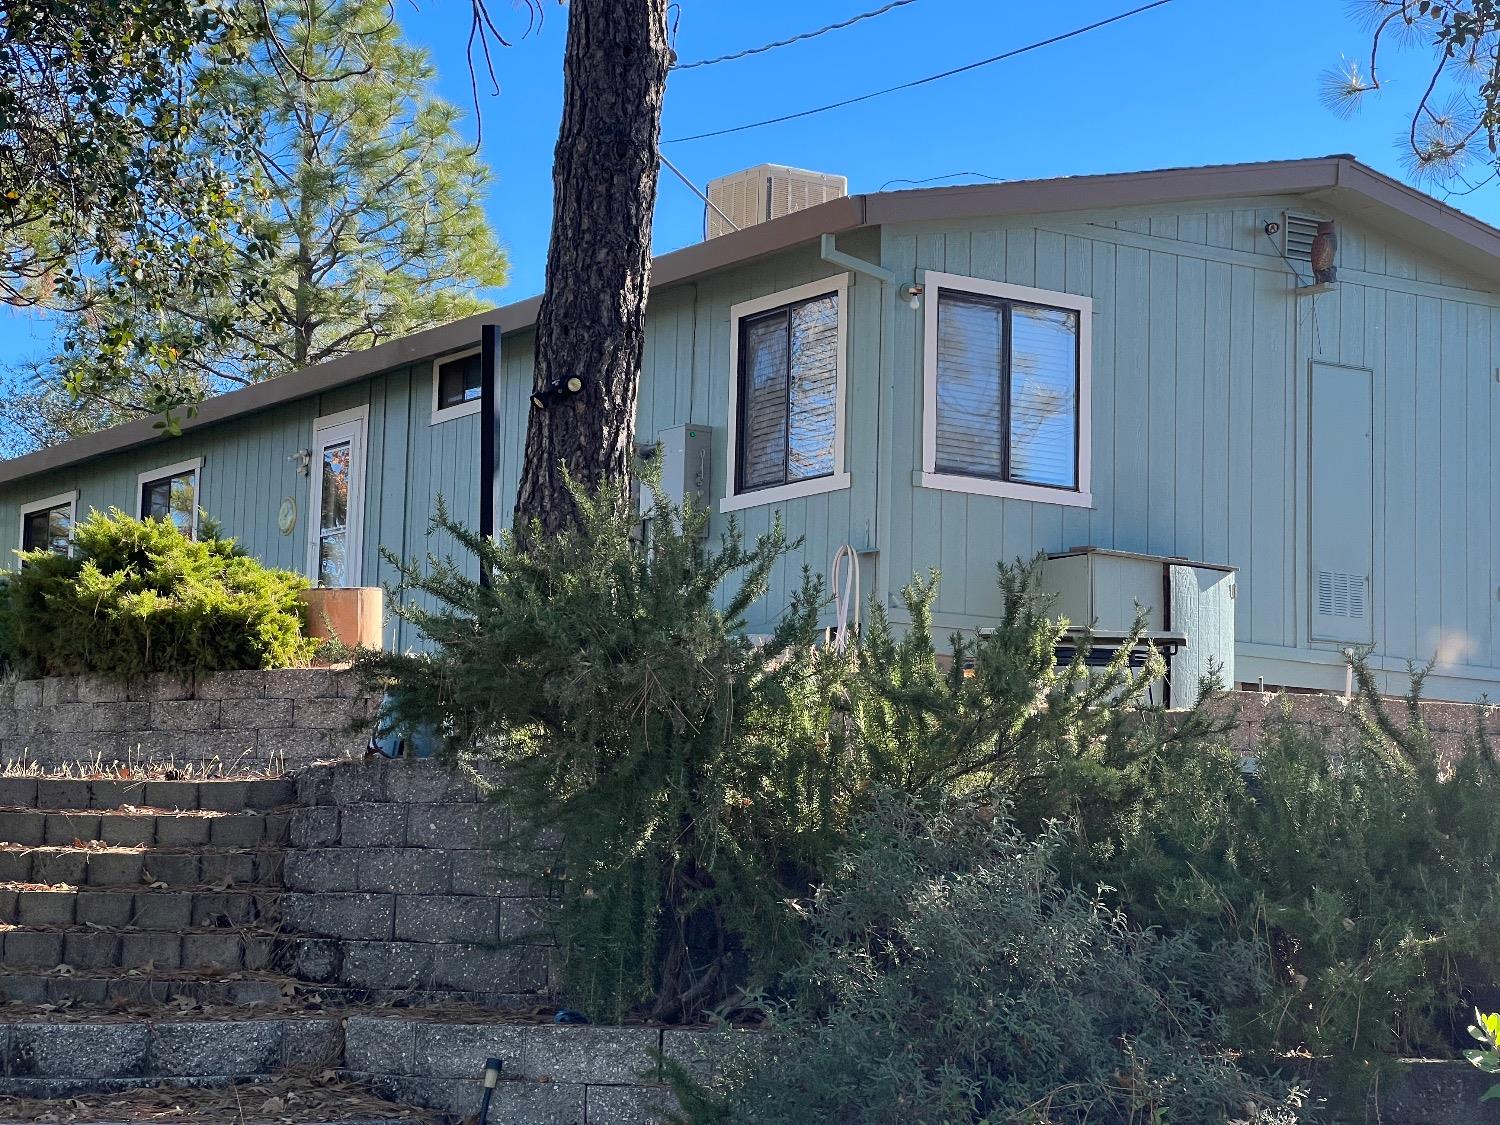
[6,510,312,678]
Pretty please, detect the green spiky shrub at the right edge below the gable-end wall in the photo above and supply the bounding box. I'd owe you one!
[1074,662,1500,1083]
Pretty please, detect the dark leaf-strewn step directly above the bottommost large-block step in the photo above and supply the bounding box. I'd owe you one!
[0,969,292,1019]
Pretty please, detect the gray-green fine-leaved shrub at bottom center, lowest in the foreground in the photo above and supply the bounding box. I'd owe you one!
[669,797,1299,1125]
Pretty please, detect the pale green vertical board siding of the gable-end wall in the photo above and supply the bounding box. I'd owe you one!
[882,200,1500,698]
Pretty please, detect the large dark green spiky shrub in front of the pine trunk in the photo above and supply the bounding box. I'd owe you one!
[359,480,851,1020]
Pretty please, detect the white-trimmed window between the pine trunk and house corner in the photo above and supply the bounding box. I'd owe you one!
[720,276,849,512]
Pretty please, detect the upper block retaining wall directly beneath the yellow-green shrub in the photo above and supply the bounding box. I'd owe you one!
[0,669,380,773]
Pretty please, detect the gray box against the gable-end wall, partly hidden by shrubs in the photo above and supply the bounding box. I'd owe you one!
[1041,548,1236,707]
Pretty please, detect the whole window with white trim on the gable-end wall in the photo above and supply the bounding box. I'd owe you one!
[918,273,1092,506]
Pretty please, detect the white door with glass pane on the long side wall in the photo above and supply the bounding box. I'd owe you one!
[308,410,366,587]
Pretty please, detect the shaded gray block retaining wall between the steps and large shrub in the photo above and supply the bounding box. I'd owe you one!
[282,759,549,1007]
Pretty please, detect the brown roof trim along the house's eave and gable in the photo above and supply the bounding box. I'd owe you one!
[0,156,1500,485]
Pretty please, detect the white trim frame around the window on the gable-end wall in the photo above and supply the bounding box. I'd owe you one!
[912,270,1094,509]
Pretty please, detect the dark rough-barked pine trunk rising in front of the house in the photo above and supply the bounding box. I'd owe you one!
[515,0,669,534]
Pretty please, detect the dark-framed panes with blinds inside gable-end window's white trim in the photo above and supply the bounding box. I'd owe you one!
[935,290,1079,489]
